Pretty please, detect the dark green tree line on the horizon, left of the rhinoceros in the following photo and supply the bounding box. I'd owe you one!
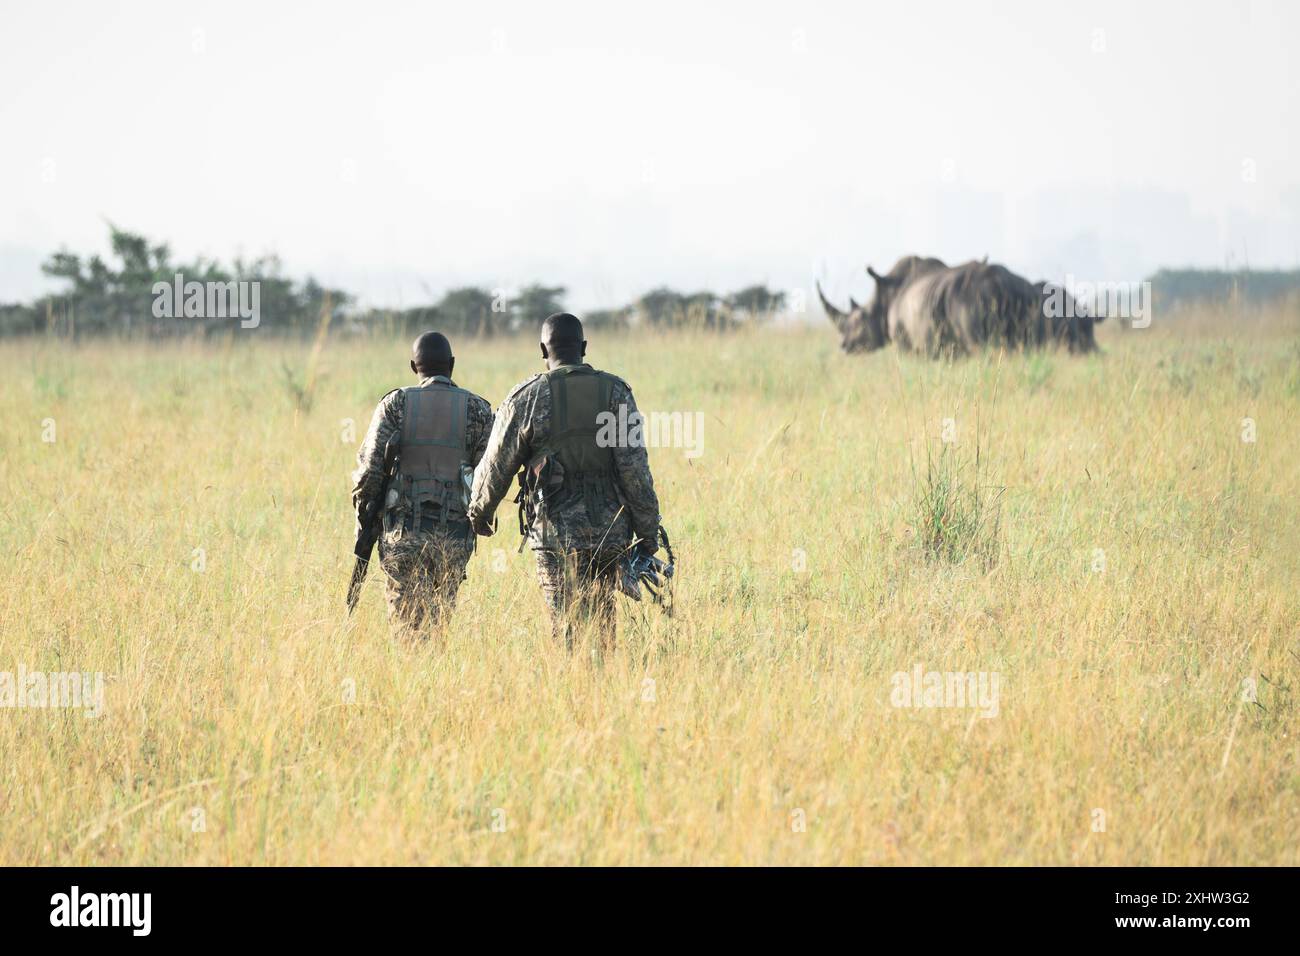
[0,225,785,338]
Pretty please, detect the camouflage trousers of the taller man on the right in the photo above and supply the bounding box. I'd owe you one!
[533,550,623,649]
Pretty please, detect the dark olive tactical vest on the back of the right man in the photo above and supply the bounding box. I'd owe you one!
[546,365,618,519]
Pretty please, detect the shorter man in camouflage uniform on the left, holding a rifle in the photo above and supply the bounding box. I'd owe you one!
[352,332,493,637]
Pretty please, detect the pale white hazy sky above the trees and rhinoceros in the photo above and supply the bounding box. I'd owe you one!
[0,0,1300,308]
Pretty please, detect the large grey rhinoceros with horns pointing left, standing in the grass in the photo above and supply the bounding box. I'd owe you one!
[818,256,1096,356]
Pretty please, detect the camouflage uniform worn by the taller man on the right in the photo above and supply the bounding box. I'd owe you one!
[469,364,659,643]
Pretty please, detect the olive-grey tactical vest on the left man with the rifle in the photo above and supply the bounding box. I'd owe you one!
[398,381,469,528]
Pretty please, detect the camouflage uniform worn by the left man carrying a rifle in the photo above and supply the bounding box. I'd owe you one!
[352,376,493,637]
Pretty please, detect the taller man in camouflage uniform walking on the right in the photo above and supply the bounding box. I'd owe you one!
[469,312,659,648]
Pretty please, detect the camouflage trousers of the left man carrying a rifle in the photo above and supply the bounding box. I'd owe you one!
[380,528,475,639]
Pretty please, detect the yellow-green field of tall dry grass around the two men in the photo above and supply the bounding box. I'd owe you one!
[0,313,1300,865]
